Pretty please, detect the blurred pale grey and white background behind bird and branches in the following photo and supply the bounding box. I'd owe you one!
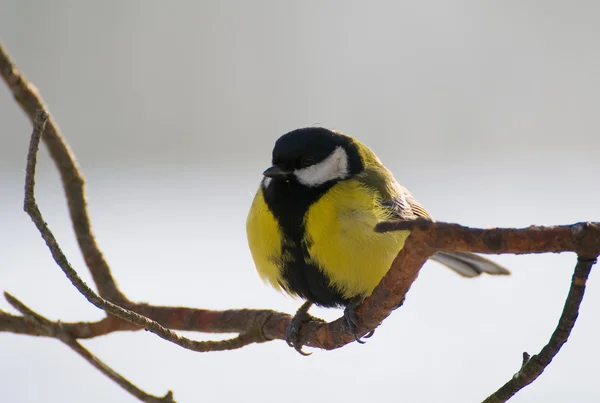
[0,0,600,403]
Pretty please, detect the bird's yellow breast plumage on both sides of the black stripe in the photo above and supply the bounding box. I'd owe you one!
[246,180,409,299]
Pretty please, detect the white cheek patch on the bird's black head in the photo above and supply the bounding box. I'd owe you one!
[294,147,348,187]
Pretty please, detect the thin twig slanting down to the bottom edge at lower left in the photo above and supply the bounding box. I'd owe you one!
[4,293,175,403]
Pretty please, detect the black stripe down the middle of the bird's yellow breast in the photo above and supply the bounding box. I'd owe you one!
[263,179,349,307]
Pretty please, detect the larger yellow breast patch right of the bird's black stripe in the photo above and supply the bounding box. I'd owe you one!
[305,180,410,298]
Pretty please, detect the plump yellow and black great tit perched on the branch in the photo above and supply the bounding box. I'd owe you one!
[246,127,510,354]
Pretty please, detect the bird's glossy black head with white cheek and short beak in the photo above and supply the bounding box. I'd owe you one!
[264,127,364,187]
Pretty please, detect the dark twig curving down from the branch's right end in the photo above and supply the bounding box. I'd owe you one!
[483,259,596,403]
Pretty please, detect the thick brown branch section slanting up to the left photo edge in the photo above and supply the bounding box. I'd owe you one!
[0,43,127,303]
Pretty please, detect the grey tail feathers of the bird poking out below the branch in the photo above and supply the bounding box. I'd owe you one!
[431,252,510,277]
